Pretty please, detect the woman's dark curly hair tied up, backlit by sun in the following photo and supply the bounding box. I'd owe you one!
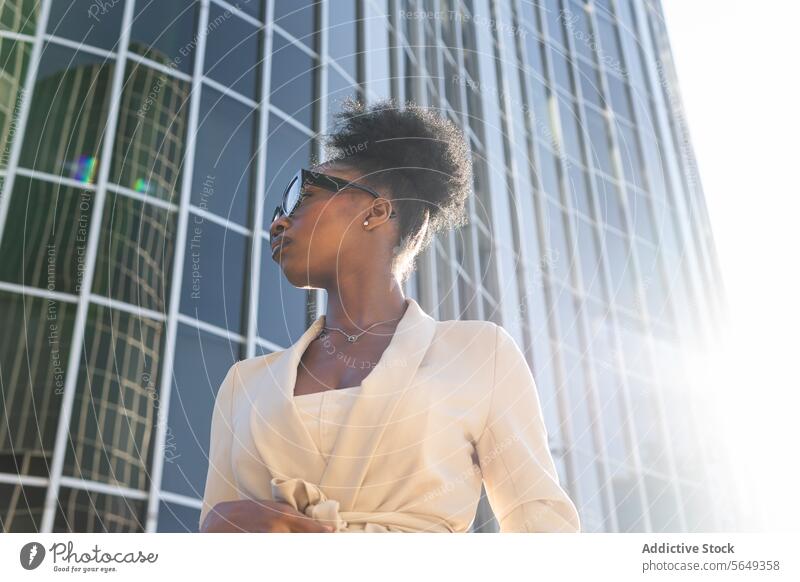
[324,97,472,281]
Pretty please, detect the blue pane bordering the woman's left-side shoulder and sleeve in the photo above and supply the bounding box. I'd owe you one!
[159,324,242,500]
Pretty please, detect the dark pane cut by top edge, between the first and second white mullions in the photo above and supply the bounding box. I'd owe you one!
[47,0,125,50]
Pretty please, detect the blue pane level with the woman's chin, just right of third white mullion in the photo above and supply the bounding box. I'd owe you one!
[181,213,250,333]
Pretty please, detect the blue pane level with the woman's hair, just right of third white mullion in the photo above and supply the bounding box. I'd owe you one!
[192,86,256,226]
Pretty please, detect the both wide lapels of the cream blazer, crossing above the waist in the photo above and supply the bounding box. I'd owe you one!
[249,297,436,508]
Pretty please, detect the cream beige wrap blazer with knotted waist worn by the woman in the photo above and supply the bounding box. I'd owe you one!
[199,297,580,532]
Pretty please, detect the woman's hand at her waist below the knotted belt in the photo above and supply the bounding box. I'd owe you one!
[200,499,333,533]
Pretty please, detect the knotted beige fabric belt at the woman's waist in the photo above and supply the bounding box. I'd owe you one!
[270,477,454,533]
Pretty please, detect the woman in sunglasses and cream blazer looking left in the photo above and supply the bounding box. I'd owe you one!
[200,100,580,532]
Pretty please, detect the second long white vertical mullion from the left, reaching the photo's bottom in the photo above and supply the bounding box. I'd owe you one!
[41,2,133,533]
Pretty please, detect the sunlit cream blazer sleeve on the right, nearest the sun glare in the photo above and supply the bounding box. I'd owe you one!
[475,325,580,533]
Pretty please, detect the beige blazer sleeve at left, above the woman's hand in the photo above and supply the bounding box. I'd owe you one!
[198,364,240,528]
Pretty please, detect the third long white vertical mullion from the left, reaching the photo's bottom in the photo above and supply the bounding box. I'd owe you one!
[145,0,209,532]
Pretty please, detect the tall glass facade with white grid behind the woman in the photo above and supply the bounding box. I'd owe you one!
[0,0,737,532]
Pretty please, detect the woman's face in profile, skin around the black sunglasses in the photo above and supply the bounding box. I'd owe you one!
[270,164,397,289]
